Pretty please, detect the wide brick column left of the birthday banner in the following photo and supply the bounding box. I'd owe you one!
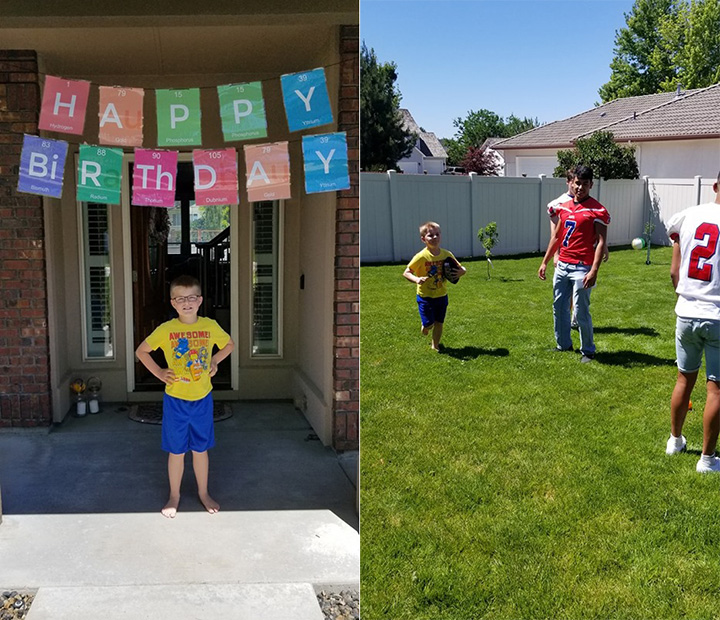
[0,50,51,427]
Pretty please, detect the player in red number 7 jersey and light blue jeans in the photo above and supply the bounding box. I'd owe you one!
[538,166,610,363]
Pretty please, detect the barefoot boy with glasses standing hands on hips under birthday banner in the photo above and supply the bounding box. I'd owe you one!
[135,276,235,518]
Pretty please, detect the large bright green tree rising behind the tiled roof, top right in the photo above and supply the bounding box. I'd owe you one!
[598,0,720,103]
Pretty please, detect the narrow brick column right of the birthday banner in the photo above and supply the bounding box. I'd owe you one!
[333,26,360,450]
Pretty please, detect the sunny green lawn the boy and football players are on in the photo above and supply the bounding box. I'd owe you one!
[360,248,720,620]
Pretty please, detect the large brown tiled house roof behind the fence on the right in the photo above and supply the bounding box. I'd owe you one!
[493,84,720,150]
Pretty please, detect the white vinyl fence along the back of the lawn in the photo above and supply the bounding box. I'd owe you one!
[360,171,715,263]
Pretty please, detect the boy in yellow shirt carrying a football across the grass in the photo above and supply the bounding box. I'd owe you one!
[403,222,466,351]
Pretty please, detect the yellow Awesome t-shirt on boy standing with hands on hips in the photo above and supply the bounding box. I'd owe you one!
[145,316,230,400]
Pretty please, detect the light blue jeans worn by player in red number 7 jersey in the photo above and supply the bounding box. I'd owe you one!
[553,261,595,355]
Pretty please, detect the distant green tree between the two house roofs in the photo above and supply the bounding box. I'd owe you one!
[444,109,539,165]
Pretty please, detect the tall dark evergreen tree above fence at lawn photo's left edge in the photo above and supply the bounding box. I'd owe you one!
[360,41,417,171]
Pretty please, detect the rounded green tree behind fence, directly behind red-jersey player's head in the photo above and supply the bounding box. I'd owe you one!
[553,131,639,180]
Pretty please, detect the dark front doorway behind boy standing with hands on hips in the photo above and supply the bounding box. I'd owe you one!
[128,162,231,392]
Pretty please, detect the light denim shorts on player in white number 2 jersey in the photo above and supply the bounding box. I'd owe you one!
[675,316,720,381]
